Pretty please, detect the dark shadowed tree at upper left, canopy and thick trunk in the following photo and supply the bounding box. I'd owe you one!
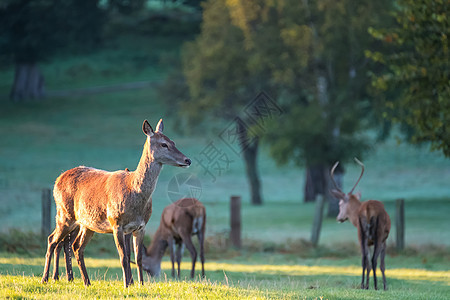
[0,0,103,101]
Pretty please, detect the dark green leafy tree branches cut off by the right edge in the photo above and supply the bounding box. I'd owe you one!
[367,0,450,157]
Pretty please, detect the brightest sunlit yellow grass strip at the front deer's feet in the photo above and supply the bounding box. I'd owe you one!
[0,276,264,299]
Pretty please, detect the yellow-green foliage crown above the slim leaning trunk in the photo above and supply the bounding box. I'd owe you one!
[180,1,253,123]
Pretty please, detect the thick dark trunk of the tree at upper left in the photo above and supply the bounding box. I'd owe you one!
[10,63,44,102]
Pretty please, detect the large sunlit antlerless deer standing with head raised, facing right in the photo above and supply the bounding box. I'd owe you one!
[42,120,191,287]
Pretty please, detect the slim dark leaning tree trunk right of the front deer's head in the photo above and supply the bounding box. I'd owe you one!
[237,122,263,205]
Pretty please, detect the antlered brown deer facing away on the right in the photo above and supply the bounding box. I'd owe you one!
[331,157,391,290]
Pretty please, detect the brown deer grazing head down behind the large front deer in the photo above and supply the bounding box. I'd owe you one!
[142,198,206,278]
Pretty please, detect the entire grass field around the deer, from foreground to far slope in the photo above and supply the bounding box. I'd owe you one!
[0,31,450,299]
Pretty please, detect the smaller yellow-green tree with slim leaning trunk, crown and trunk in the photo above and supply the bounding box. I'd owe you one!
[172,0,274,205]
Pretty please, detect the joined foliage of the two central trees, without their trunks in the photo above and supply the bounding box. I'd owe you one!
[179,0,394,165]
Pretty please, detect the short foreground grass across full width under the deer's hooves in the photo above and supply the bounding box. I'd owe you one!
[0,253,450,299]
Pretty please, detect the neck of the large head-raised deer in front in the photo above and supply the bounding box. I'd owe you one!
[133,138,162,199]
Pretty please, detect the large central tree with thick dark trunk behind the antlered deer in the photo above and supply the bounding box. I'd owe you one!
[211,0,389,216]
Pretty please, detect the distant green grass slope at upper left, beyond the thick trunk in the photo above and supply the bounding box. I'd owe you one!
[0,33,192,95]
